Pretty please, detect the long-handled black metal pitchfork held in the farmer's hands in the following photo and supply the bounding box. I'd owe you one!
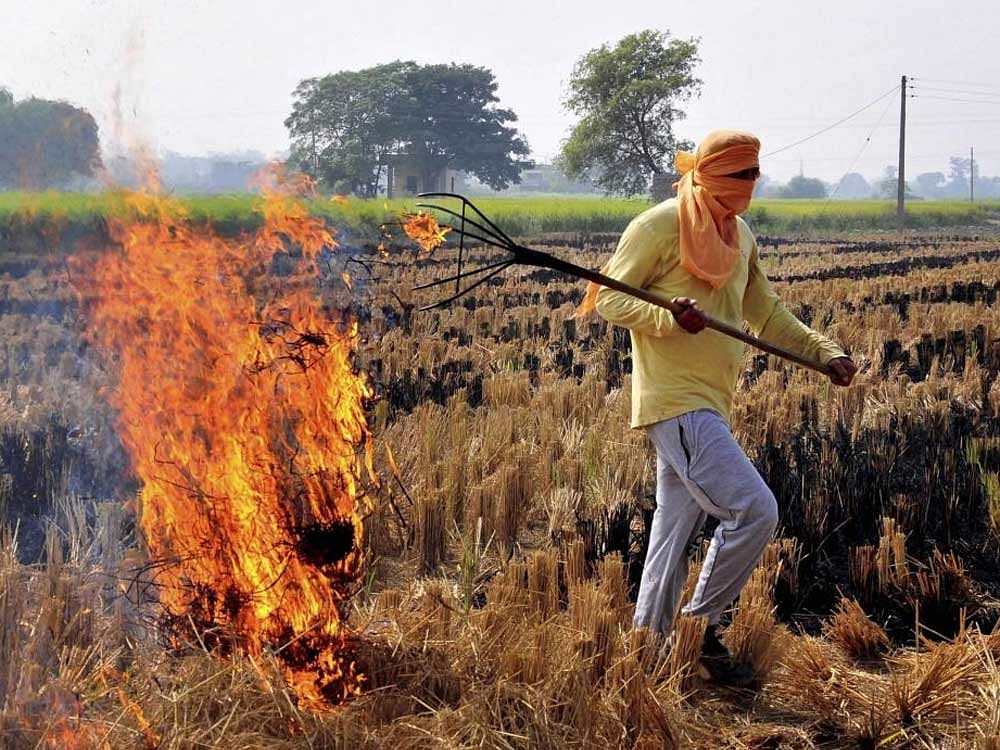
[414,193,832,375]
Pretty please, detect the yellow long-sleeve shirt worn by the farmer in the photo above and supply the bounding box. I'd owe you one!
[596,199,844,427]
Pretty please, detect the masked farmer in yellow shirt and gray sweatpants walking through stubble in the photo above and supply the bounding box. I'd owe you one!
[584,130,857,685]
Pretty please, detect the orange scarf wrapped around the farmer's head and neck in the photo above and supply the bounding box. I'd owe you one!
[674,130,760,289]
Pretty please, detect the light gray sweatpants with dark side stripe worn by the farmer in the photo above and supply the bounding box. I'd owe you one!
[634,409,778,635]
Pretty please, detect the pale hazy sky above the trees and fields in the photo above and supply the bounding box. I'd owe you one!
[0,0,1000,180]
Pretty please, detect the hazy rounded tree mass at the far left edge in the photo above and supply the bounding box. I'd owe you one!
[0,89,101,190]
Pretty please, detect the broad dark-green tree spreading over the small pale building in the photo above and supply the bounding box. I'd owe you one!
[285,61,528,197]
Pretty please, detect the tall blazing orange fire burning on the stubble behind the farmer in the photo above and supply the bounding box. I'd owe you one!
[77,179,370,707]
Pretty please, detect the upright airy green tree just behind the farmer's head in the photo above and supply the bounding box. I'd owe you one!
[560,30,701,195]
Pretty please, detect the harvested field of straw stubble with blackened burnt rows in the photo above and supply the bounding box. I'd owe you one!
[0,197,1000,750]
